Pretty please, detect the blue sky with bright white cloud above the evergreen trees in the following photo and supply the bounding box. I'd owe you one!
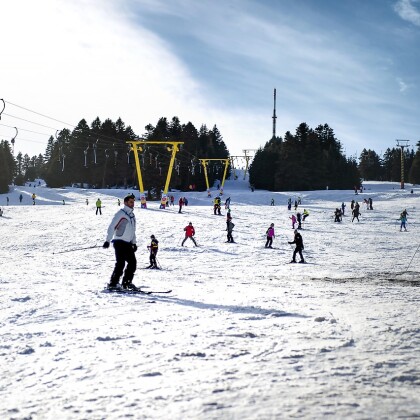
[0,0,420,156]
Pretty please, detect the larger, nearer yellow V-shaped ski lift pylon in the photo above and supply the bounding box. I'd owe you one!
[126,140,184,209]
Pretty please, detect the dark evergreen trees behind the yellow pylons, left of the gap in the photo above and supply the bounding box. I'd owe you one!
[0,117,229,194]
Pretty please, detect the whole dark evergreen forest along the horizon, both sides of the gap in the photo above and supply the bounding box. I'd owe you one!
[0,117,420,194]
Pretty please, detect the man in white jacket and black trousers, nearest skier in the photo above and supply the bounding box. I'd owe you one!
[103,194,137,290]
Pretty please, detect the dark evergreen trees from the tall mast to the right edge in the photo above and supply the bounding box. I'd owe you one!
[249,123,420,191]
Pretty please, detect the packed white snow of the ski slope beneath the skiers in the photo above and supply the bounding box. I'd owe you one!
[0,176,420,419]
